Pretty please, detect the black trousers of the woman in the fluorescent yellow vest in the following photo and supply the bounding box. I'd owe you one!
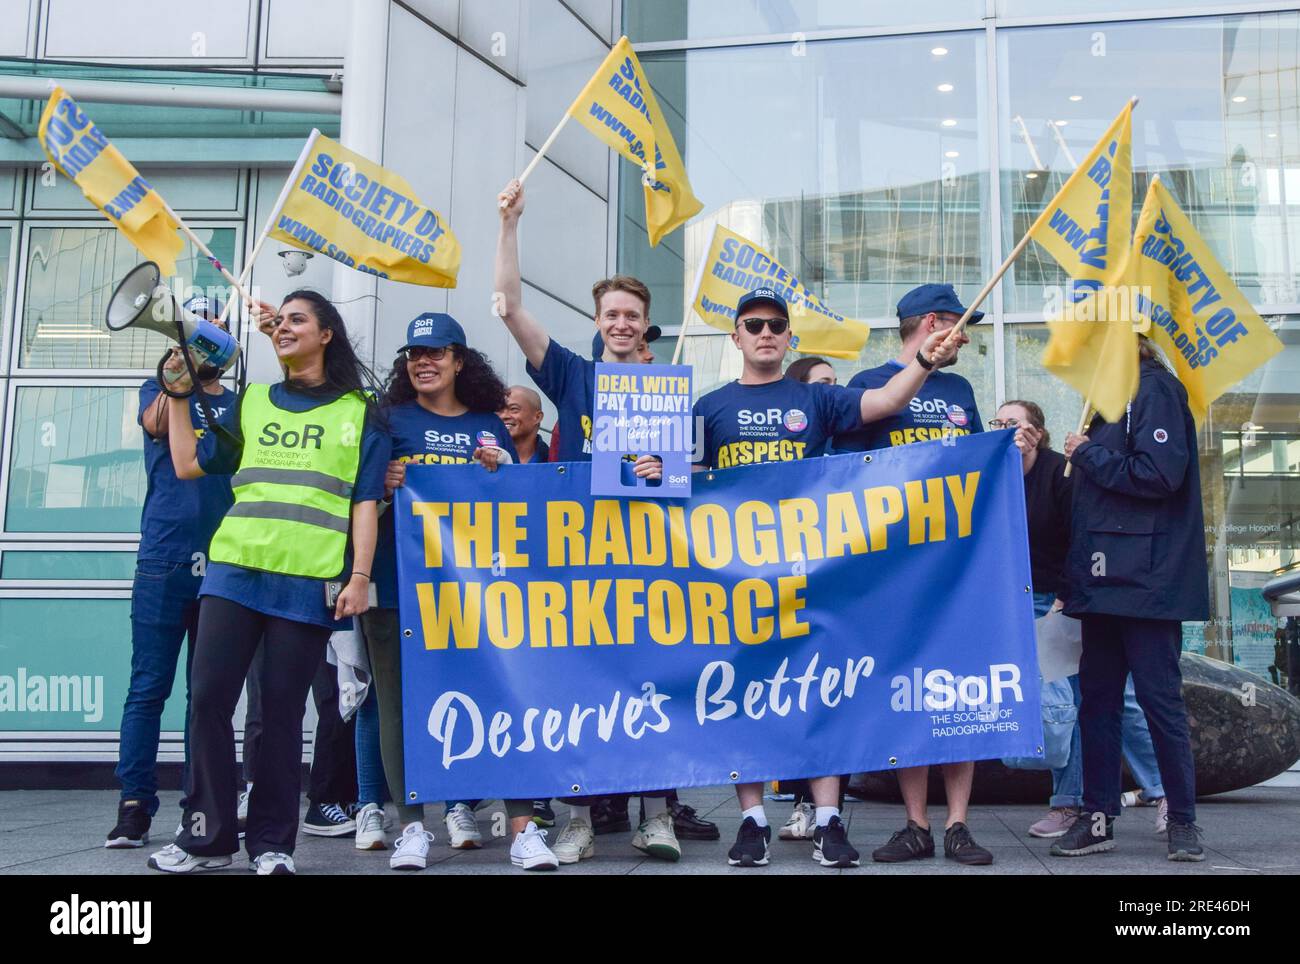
[176,596,330,856]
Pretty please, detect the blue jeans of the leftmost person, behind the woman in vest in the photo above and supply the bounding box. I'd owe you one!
[116,559,203,817]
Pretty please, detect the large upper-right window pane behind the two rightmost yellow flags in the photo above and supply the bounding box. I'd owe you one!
[998,12,1300,312]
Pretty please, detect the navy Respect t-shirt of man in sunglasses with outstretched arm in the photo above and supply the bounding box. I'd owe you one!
[694,378,862,469]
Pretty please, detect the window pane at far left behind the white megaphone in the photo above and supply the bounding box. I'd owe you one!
[17,227,235,372]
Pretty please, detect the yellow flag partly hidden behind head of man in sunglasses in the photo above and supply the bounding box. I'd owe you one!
[694,225,871,361]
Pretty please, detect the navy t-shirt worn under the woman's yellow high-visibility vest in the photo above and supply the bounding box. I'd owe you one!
[198,382,389,630]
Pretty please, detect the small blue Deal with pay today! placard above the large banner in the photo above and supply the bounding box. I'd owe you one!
[592,361,694,499]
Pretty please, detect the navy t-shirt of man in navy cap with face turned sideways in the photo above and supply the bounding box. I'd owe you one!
[833,361,984,452]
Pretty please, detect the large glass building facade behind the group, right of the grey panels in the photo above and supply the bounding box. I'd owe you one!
[618,0,1300,676]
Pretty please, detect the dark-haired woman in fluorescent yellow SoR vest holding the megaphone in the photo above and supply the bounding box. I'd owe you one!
[148,291,389,874]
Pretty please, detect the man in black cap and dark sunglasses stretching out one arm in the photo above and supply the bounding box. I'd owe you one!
[694,288,957,867]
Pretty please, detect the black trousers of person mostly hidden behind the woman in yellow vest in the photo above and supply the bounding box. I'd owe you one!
[243,650,358,803]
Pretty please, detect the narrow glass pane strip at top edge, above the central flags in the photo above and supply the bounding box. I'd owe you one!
[623,0,984,42]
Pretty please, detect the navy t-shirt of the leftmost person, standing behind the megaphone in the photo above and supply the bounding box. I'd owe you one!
[135,378,235,563]
